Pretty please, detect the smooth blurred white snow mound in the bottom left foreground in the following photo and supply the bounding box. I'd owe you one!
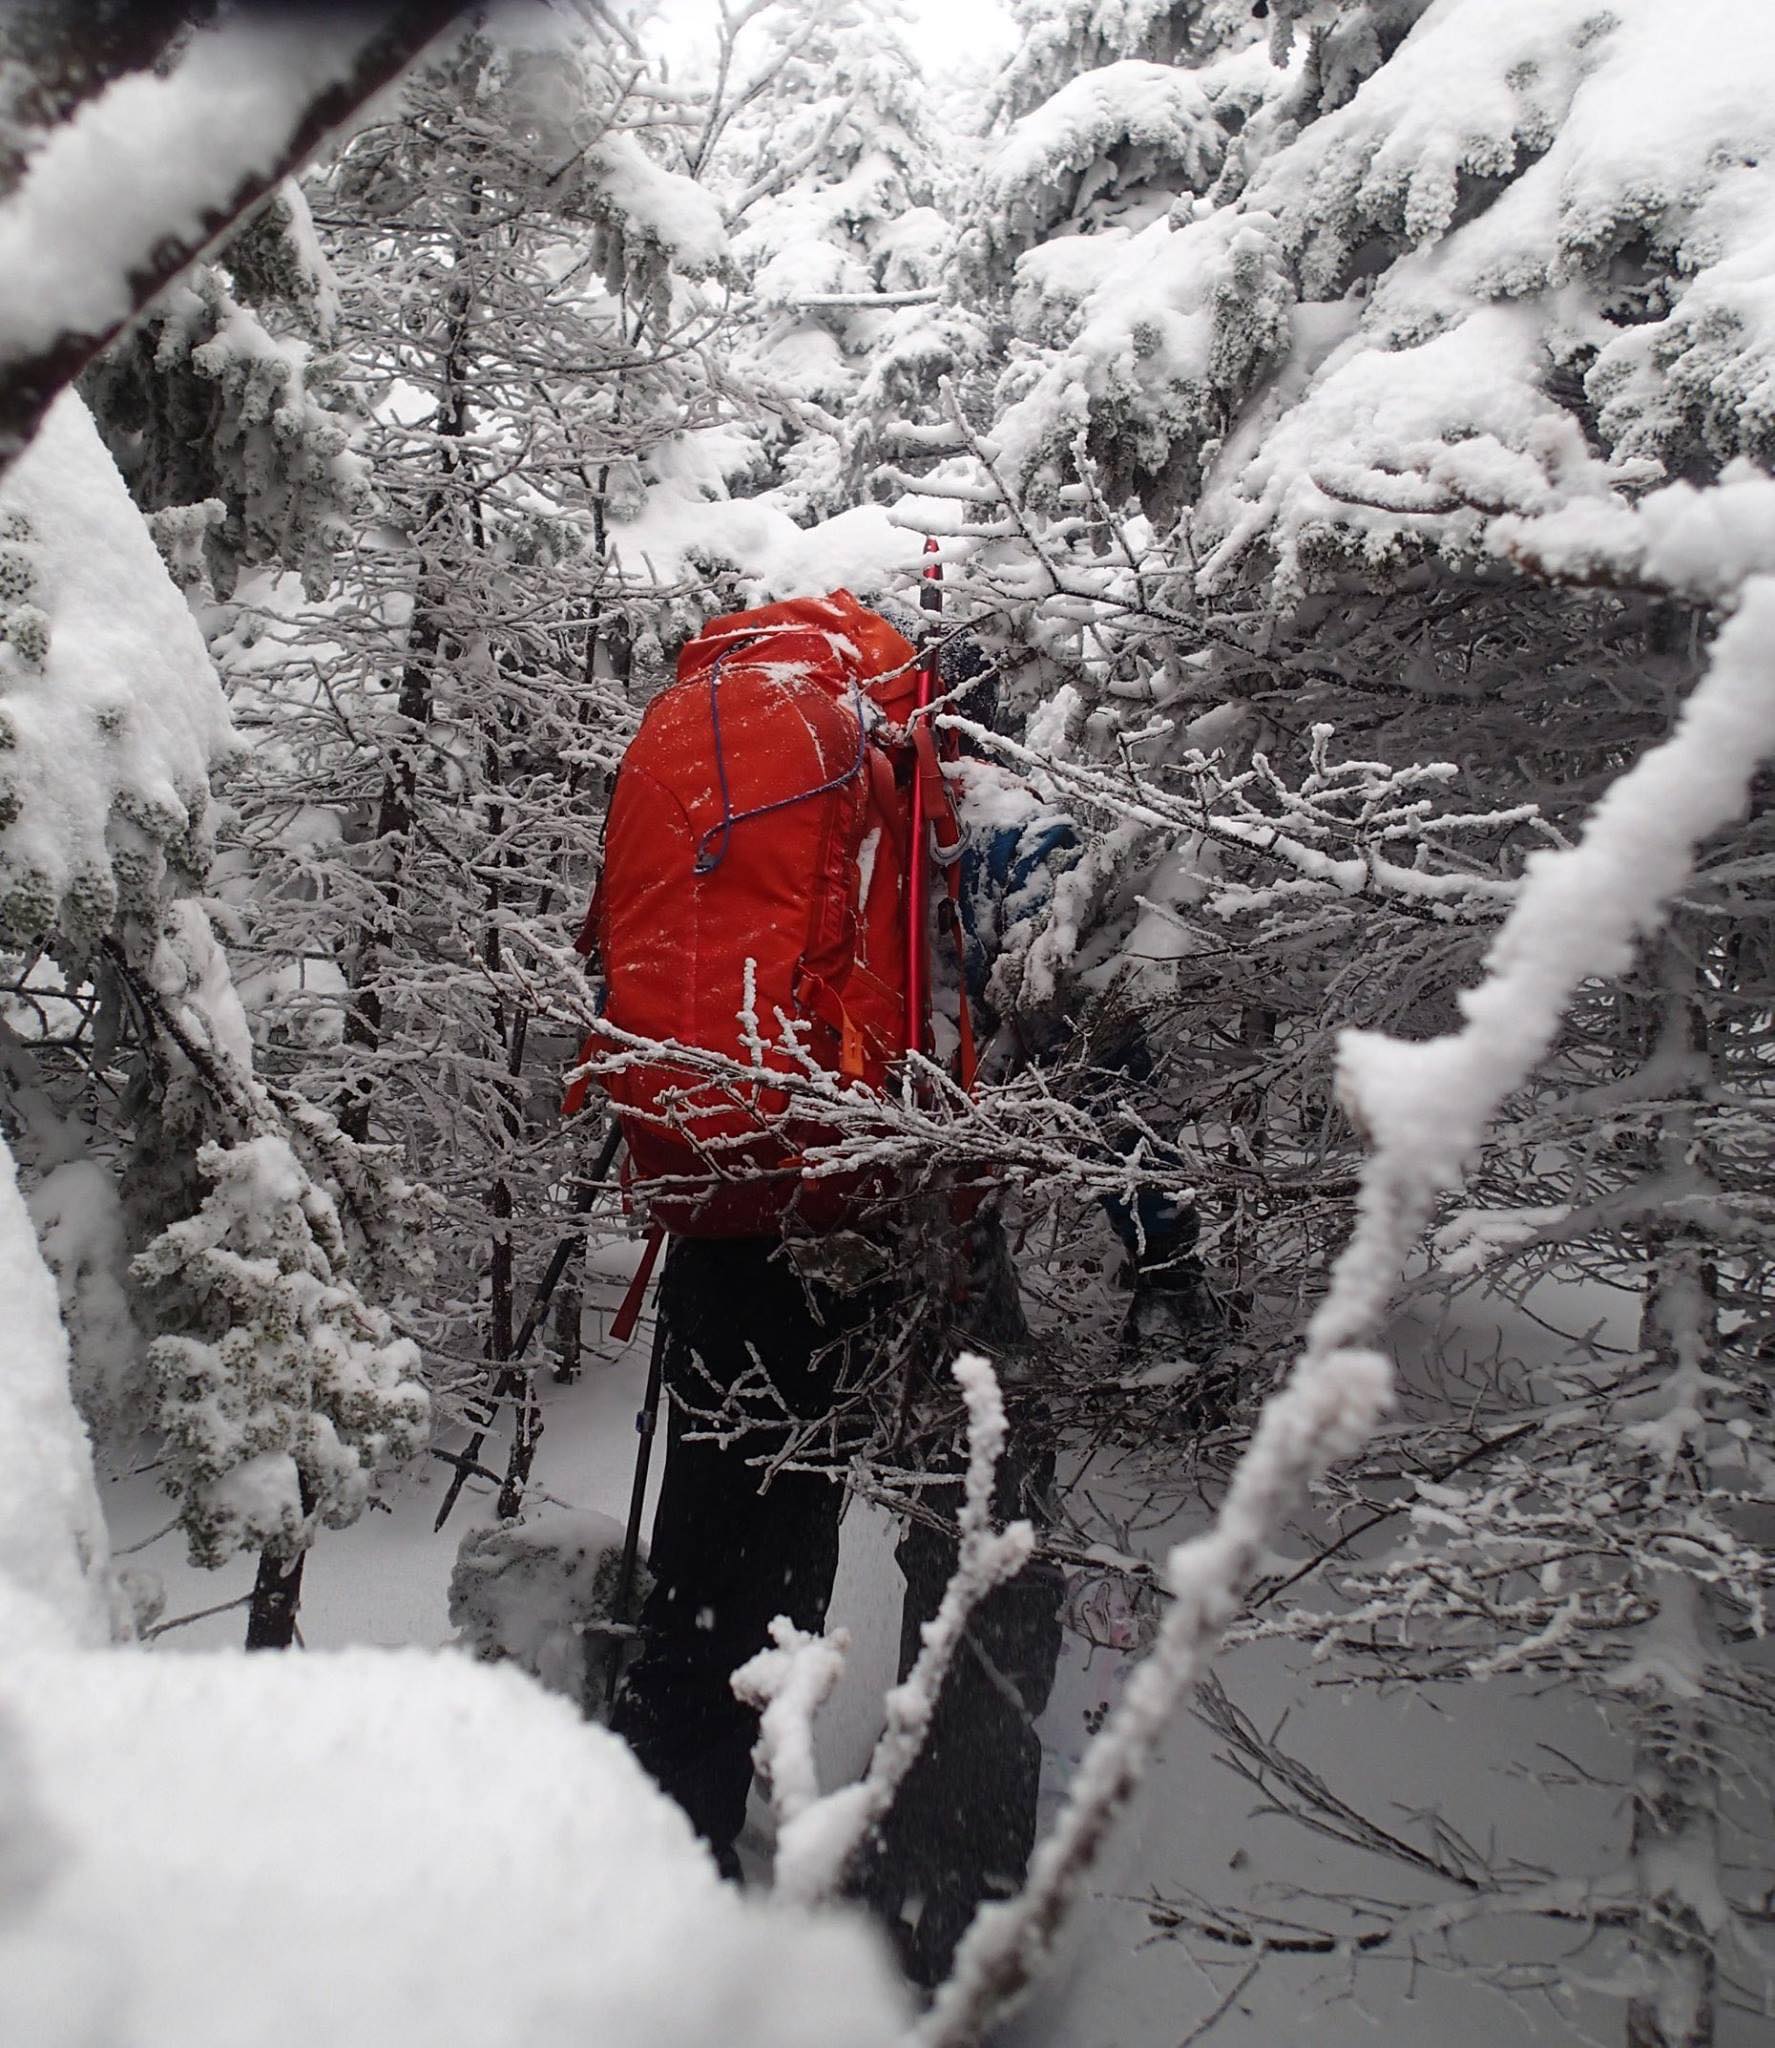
[0,1651,903,2048]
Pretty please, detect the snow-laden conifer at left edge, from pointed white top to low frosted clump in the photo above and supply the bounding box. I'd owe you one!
[0,393,426,1646]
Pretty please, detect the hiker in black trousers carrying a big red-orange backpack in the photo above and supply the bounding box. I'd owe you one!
[588,592,1187,1982]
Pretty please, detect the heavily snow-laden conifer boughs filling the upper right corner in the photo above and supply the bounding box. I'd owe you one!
[995,0,1775,598]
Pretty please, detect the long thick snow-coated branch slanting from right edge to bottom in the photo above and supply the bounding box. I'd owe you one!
[915,578,1775,2048]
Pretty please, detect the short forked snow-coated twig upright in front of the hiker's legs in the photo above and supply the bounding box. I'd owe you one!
[733,1352,1036,1905]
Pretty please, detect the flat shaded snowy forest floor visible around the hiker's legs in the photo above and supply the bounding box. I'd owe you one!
[106,1260,1755,2048]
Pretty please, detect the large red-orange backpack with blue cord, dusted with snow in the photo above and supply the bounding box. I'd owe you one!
[565,590,958,1237]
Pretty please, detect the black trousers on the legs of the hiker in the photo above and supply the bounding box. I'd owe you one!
[612,1239,1063,1985]
